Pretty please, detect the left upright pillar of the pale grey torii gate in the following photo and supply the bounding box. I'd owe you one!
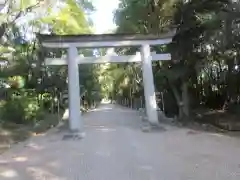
[68,46,83,134]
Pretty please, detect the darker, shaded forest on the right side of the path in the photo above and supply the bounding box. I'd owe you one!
[106,0,240,129]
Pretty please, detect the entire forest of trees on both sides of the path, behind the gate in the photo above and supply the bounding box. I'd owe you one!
[0,0,240,135]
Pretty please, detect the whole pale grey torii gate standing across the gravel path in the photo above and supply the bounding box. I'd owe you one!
[38,30,175,133]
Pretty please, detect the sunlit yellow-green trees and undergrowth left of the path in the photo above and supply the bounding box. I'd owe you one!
[0,0,100,139]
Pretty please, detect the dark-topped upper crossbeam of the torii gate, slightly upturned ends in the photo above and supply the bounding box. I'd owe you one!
[38,30,175,48]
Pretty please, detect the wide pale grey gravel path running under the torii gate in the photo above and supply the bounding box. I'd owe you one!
[0,105,240,180]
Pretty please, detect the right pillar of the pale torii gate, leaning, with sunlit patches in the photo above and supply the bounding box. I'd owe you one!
[141,44,158,125]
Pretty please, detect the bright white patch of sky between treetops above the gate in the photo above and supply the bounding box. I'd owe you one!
[92,0,118,34]
